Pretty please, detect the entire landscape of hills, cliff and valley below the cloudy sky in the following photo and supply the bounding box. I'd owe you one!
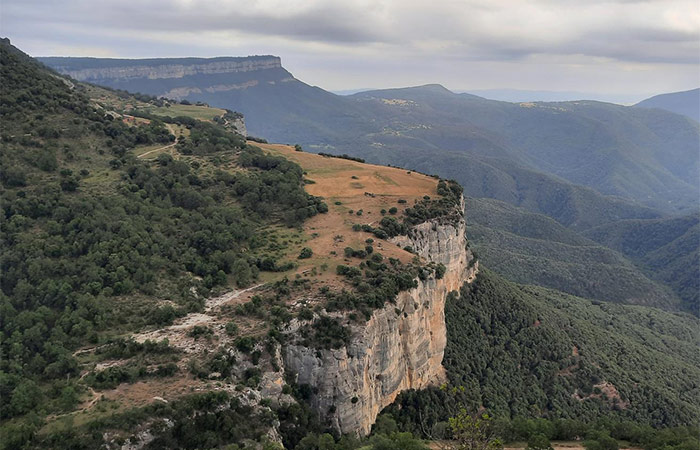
[0,36,700,450]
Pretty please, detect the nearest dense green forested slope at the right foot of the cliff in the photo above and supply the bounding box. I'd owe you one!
[388,270,700,433]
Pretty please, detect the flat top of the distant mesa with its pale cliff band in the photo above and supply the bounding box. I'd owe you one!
[38,55,282,83]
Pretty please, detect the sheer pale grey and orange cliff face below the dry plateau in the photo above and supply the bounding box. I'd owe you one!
[284,200,478,434]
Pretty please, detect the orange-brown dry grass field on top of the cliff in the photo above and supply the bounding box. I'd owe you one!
[250,142,438,281]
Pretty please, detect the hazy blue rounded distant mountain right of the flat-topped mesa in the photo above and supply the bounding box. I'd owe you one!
[350,87,700,209]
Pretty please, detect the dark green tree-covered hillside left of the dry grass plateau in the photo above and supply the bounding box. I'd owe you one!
[0,41,327,448]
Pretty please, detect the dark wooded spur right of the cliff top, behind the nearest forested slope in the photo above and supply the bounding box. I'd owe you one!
[467,198,680,309]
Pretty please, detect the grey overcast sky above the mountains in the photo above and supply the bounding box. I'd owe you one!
[0,0,700,101]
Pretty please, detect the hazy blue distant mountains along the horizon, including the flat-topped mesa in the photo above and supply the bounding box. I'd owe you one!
[40,57,700,212]
